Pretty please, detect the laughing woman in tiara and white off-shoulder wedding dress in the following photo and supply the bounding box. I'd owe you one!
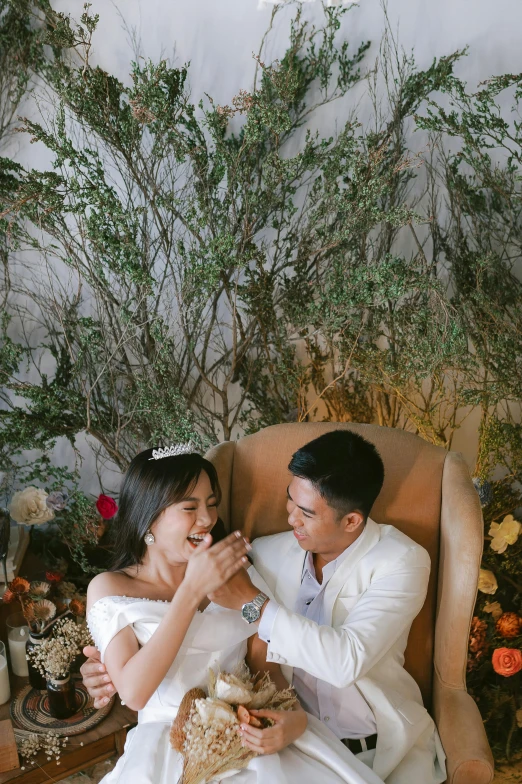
[87,449,382,784]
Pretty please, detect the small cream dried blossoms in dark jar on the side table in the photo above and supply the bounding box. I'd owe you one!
[28,618,93,679]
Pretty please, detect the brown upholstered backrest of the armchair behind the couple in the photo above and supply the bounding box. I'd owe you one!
[208,422,468,707]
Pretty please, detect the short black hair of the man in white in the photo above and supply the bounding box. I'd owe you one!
[288,430,384,519]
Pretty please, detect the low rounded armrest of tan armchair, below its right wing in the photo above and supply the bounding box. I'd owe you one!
[433,673,494,784]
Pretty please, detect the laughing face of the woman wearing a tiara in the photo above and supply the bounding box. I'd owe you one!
[151,471,218,563]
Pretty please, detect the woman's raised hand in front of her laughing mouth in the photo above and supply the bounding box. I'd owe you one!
[183,531,250,601]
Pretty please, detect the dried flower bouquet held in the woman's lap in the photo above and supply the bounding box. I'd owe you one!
[170,664,297,784]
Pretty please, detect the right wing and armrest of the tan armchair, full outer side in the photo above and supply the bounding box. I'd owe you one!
[433,452,494,784]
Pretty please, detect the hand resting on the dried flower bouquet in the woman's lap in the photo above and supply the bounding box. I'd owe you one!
[238,706,308,754]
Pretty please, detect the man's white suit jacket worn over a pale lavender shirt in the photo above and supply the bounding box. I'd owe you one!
[251,519,446,784]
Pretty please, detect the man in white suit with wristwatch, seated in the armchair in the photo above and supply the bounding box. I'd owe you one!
[82,430,446,784]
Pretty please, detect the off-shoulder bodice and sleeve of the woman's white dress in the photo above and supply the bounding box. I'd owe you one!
[87,596,257,721]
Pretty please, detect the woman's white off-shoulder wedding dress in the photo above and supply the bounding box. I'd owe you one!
[87,596,382,784]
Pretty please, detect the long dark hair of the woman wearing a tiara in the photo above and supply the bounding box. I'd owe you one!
[110,449,223,572]
